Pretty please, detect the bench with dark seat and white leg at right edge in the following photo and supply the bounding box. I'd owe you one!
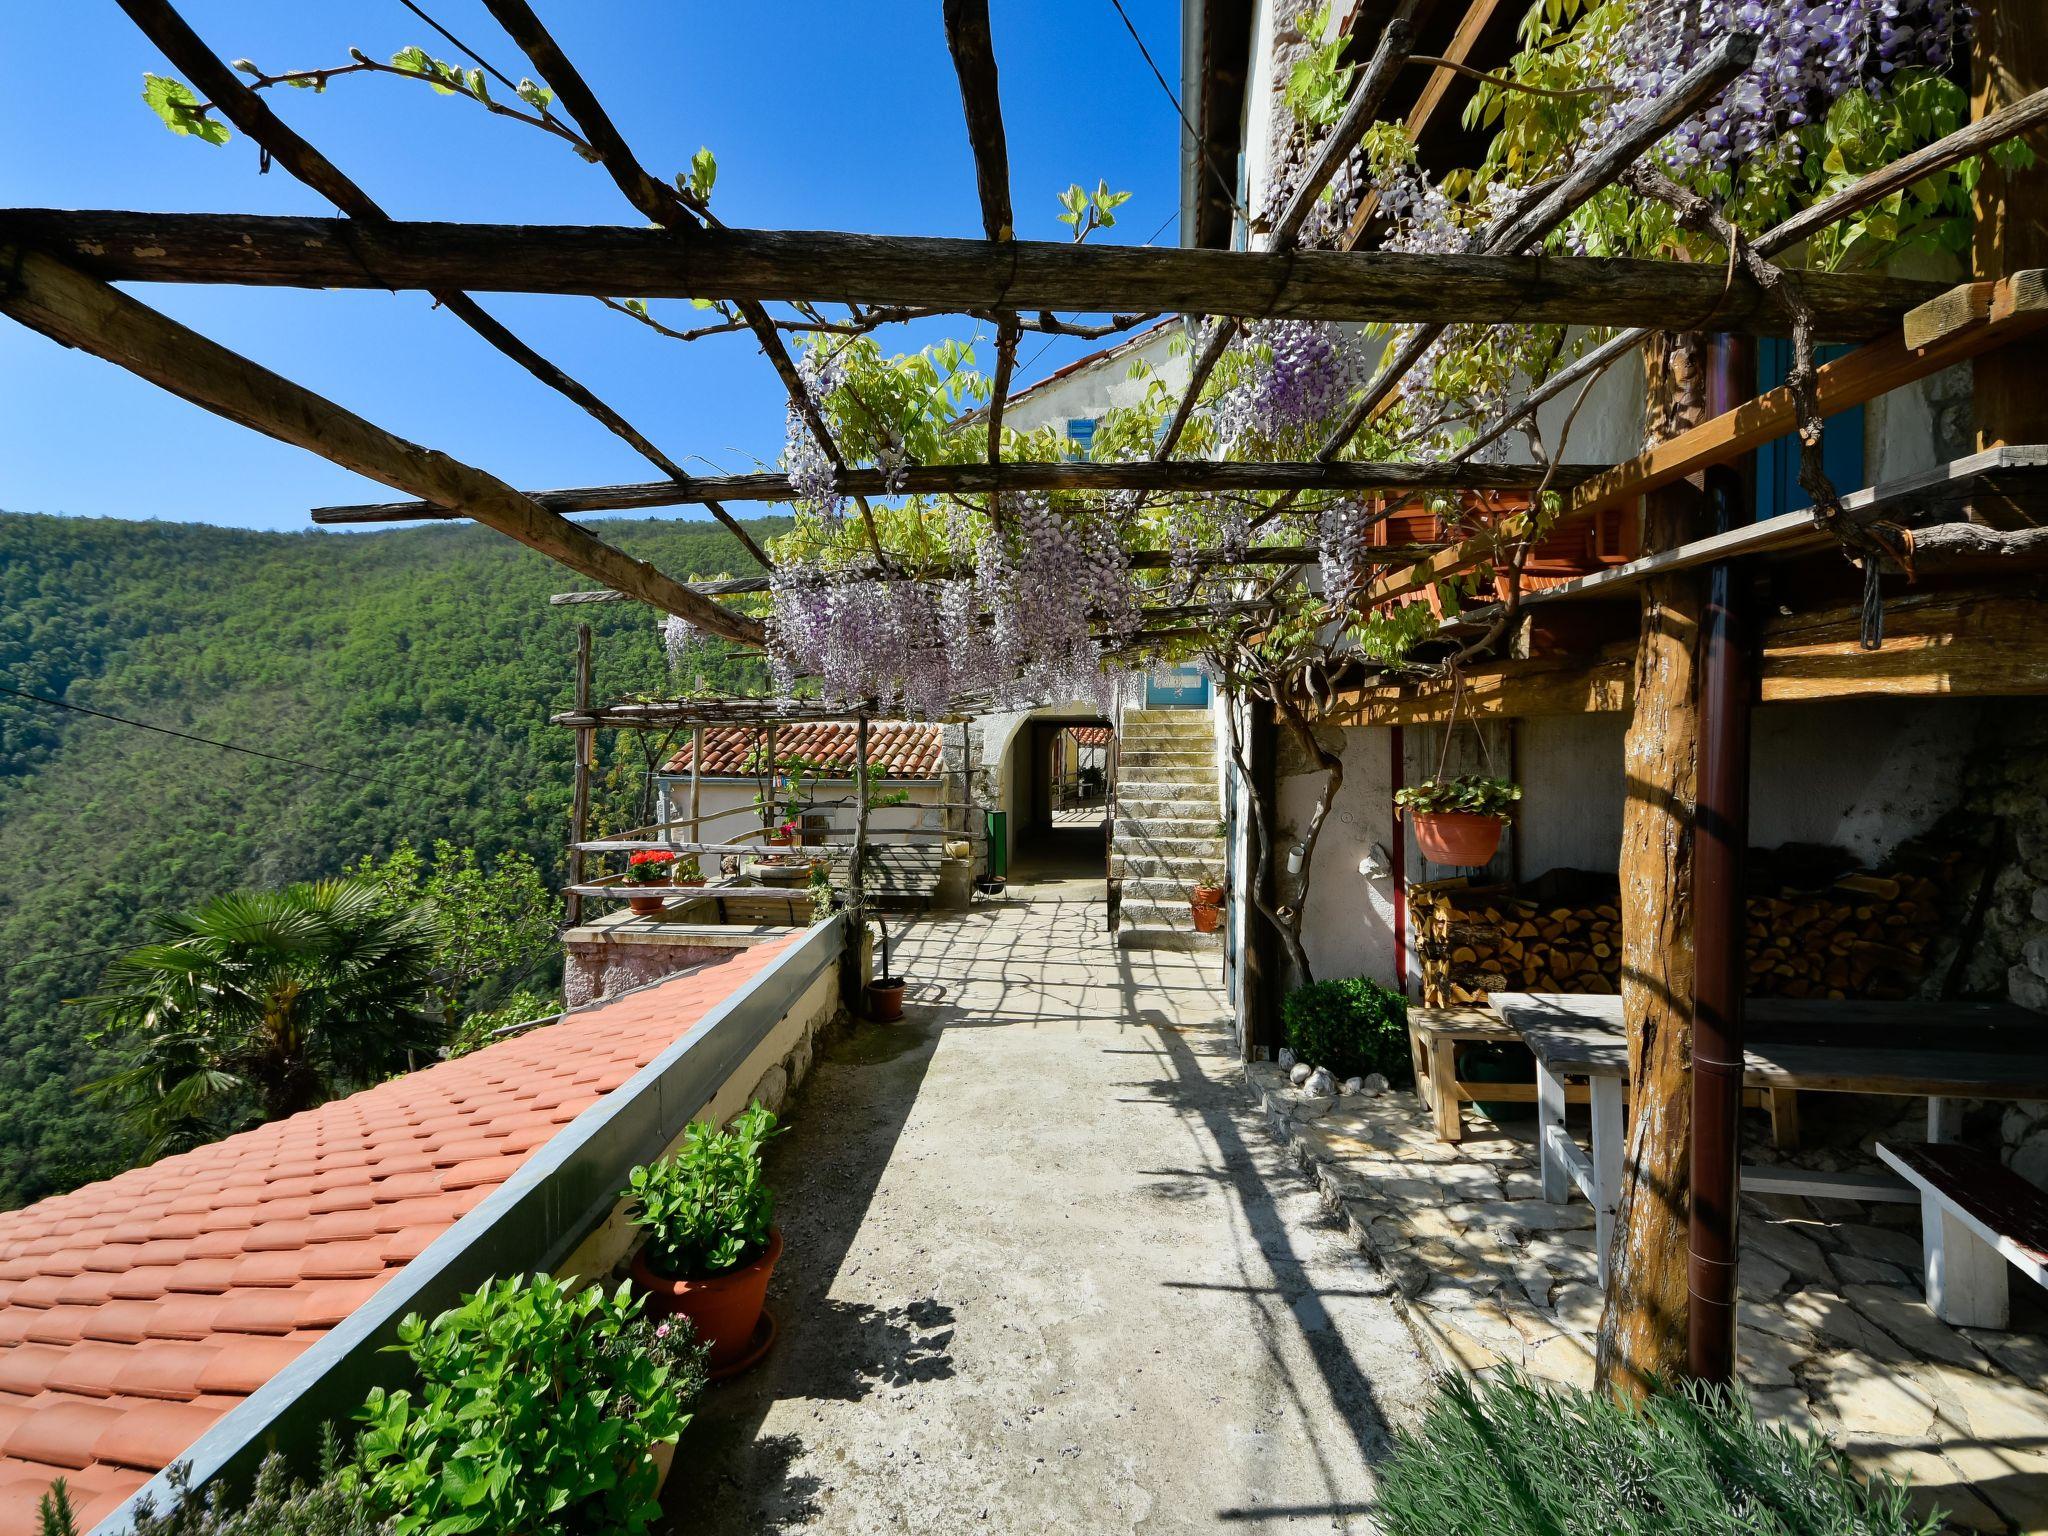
[1878,1143,2048,1327]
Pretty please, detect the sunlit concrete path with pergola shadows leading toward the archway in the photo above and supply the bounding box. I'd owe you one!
[668,881,1430,1536]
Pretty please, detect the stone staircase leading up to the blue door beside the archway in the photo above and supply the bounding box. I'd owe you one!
[1110,709,1223,950]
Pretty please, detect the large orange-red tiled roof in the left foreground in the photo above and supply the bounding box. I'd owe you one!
[0,936,795,1536]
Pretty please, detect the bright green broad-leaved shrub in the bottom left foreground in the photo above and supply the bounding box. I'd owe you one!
[356,1274,696,1536]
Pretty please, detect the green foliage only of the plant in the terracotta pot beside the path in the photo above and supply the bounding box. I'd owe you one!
[625,1104,774,1280]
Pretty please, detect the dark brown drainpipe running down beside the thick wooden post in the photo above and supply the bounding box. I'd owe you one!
[1686,336,1757,1384]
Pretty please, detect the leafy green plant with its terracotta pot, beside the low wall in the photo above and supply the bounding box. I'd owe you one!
[625,1104,782,1376]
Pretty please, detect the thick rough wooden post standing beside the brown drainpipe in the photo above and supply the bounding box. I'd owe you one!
[1595,332,1706,1397]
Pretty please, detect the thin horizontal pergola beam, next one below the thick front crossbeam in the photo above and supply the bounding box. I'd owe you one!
[313,459,1587,524]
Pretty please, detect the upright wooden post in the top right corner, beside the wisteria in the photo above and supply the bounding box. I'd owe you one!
[1970,0,2048,449]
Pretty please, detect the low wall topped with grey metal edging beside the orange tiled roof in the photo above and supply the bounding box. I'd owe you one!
[92,918,846,1536]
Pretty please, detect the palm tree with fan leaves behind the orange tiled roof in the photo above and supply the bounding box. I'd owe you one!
[82,881,444,1157]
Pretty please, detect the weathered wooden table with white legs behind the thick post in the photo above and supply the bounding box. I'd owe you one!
[1489,991,2048,1282]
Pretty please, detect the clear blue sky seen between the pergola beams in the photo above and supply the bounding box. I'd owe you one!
[0,0,1180,528]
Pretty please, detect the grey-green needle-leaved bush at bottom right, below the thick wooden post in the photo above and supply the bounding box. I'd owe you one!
[1372,1374,1942,1536]
